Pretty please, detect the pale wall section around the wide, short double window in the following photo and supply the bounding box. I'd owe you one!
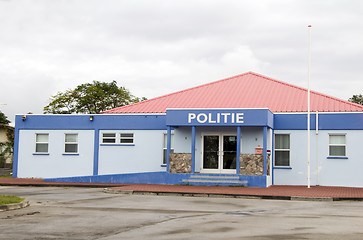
[98,130,166,175]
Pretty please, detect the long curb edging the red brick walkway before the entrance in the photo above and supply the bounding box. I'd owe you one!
[103,188,342,202]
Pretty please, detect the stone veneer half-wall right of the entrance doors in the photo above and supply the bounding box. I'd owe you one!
[239,154,270,175]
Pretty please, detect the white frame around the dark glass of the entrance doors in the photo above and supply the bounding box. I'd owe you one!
[200,132,242,174]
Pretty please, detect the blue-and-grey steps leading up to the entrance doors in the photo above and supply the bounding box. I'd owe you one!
[182,175,248,186]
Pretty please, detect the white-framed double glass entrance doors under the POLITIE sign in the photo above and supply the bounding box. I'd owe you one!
[201,134,237,174]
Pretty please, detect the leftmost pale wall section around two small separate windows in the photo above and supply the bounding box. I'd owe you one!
[18,130,94,178]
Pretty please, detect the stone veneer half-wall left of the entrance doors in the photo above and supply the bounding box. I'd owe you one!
[169,153,192,173]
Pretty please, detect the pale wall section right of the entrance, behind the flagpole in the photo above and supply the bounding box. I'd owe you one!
[274,130,363,187]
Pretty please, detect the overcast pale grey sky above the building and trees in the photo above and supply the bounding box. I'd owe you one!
[0,0,363,124]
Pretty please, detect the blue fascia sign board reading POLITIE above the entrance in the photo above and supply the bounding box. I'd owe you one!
[166,109,273,127]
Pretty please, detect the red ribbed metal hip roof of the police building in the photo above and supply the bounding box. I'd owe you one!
[103,72,363,113]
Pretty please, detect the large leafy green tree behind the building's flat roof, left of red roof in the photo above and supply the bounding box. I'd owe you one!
[44,81,146,114]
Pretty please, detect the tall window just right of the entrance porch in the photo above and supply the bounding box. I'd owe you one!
[275,134,290,167]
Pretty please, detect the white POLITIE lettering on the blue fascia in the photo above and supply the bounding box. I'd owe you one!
[188,113,244,123]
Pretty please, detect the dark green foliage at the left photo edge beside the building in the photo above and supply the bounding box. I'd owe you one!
[0,111,14,167]
